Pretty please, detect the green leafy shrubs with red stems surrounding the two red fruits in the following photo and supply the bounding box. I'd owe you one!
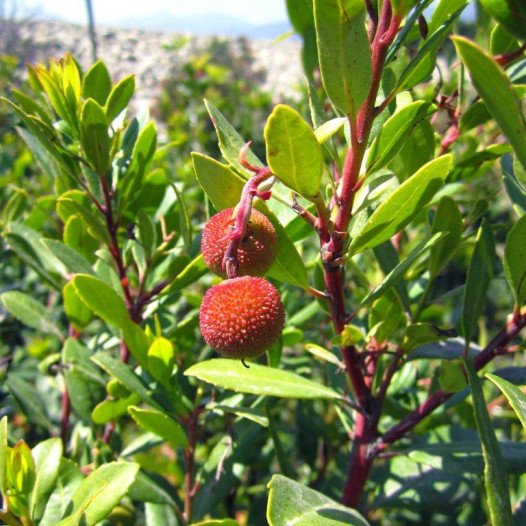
[0,0,526,526]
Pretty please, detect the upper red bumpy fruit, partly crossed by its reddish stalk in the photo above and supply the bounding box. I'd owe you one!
[201,208,278,278]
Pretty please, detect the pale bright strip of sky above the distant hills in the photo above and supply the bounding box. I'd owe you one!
[21,0,287,25]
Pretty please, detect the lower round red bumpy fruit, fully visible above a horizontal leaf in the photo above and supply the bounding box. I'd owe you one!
[199,276,285,358]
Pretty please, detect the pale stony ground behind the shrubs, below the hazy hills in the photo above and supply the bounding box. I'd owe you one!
[11,17,302,107]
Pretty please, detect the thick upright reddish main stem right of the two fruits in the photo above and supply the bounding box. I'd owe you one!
[314,1,400,507]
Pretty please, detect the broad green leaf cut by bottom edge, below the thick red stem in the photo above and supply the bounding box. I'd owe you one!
[267,475,369,526]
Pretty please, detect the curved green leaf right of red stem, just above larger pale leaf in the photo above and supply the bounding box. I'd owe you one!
[365,100,437,172]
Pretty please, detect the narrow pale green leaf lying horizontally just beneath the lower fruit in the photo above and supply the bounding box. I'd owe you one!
[184,358,341,400]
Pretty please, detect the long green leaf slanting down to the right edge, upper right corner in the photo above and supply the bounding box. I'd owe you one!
[452,36,526,173]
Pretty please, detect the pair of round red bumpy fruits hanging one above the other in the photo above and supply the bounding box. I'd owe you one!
[199,208,285,358]
